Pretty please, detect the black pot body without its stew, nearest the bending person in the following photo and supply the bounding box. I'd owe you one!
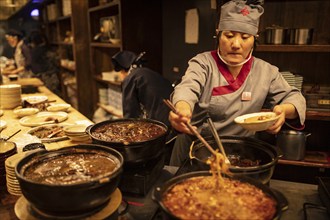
[86,118,168,165]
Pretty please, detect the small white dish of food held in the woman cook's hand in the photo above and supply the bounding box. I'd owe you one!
[234,112,280,131]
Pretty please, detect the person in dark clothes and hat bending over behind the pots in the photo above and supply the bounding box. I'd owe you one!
[112,51,173,127]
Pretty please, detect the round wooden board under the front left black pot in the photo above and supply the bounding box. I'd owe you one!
[15,188,122,220]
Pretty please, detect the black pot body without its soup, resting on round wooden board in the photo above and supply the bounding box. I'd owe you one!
[15,144,123,216]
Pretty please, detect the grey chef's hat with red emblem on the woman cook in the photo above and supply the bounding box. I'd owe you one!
[219,0,264,35]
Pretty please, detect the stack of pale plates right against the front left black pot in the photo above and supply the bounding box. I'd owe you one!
[5,152,28,196]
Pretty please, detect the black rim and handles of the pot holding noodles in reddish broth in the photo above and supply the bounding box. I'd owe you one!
[152,171,287,219]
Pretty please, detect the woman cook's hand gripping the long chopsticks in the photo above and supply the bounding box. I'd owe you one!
[169,101,193,135]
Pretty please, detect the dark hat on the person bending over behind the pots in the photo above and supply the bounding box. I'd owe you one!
[111,50,137,72]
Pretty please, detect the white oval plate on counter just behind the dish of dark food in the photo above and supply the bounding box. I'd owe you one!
[19,112,68,127]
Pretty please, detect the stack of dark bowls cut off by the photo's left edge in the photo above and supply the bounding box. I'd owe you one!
[0,140,17,187]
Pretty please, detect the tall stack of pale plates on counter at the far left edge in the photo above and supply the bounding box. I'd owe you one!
[0,84,22,109]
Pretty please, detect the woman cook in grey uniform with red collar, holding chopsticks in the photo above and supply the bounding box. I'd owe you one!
[169,0,306,166]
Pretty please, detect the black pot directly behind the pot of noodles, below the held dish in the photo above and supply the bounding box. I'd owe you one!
[192,136,281,184]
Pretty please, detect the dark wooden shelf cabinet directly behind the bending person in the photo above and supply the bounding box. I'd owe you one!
[87,0,162,116]
